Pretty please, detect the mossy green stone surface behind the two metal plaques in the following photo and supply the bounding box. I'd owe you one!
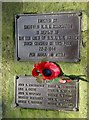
[2,2,89,118]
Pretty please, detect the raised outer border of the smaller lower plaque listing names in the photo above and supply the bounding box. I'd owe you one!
[14,75,79,112]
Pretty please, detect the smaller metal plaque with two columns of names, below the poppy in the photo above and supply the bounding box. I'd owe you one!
[15,76,78,111]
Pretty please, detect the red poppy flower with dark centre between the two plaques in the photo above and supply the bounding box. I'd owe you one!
[32,62,61,80]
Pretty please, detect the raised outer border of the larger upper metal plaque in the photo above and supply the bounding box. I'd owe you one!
[14,11,82,62]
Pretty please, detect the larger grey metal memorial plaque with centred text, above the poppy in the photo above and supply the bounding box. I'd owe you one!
[15,12,82,62]
